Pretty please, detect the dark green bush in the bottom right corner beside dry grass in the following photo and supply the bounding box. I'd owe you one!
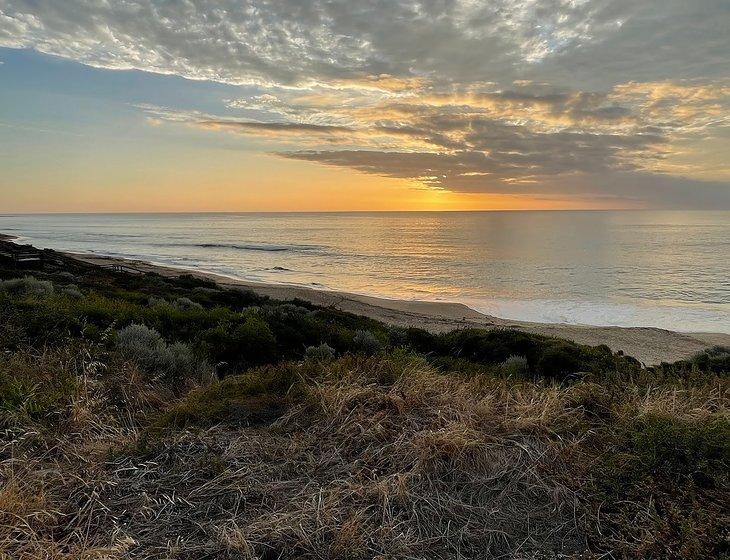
[584,414,730,560]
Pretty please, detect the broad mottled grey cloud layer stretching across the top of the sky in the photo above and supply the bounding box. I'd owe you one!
[0,0,730,89]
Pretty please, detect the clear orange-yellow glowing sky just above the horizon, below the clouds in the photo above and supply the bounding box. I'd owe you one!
[0,151,626,213]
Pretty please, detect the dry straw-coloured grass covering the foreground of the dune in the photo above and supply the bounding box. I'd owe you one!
[0,357,728,560]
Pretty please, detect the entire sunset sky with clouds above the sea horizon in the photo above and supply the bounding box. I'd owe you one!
[0,0,730,213]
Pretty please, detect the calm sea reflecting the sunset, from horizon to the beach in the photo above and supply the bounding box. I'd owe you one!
[0,211,730,332]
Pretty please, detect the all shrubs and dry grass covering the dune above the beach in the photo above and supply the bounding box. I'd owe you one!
[0,247,730,560]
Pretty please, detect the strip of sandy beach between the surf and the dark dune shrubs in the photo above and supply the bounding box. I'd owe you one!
[66,249,730,365]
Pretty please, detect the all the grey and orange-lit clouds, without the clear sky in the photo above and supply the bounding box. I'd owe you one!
[0,0,730,208]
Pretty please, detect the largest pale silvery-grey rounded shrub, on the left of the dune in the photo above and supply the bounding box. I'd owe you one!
[117,324,209,380]
